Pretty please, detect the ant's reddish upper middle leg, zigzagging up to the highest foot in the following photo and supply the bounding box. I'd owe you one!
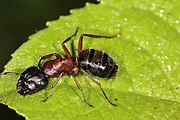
[61,28,79,58]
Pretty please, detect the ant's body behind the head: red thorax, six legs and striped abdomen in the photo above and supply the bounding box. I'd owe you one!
[38,29,118,107]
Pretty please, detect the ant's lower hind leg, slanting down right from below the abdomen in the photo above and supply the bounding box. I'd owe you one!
[81,69,117,106]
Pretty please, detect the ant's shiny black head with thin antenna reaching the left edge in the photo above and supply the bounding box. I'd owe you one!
[0,66,48,95]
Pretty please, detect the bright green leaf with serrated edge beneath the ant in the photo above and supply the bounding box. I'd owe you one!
[0,0,180,120]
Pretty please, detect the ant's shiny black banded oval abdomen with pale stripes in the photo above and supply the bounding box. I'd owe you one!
[79,49,118,78]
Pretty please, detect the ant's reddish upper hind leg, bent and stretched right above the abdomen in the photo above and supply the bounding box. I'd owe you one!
[78,34,117,55]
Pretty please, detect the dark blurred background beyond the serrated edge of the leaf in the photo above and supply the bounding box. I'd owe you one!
[0,0,98,120]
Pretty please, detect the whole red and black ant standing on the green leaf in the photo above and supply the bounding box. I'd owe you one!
[0,28,118,107]
